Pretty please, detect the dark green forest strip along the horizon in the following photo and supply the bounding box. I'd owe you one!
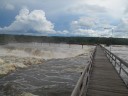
[0,34,128,45]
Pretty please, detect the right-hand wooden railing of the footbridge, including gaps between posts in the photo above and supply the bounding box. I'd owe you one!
[101,46,128,87]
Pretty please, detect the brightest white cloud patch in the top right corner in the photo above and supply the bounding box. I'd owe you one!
[84,0,128,18]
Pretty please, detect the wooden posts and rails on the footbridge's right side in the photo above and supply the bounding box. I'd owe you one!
[100,45,128,87]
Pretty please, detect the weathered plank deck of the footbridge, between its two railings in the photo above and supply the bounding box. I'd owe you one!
[86,46,128,96]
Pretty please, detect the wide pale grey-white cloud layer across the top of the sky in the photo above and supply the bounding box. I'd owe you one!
[0,0,128,18]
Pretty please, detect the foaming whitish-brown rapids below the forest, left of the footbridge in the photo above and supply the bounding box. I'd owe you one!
[0,43,93,74]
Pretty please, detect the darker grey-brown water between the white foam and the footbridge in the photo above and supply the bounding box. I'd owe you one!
[0,43,93,96]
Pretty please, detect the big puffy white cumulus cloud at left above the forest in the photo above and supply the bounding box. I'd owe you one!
[1,8,55,34]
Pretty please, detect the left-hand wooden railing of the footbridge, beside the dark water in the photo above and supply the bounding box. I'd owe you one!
[71,48,96,96]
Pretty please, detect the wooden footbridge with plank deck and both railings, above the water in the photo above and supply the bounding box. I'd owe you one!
[71,46,128,96]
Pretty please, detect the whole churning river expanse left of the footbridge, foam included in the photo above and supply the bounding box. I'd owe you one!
[0,43,94,96]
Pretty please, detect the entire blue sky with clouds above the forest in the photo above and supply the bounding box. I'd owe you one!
[0,0,128,38]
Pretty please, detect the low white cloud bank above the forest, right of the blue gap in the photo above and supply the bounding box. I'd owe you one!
[71,17,113,37]
